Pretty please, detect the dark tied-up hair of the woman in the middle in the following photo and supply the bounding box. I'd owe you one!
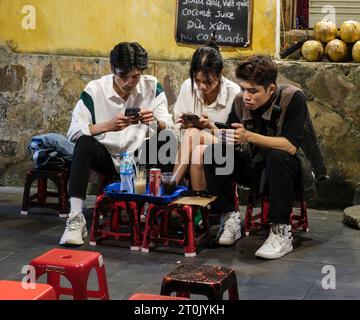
[189,38,224,87]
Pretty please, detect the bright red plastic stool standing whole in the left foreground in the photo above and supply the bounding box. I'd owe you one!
[30,249,109,300]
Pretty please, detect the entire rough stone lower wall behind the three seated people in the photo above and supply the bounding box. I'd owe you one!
[0,47,360,208]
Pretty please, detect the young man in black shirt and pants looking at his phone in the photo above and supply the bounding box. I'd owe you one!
[205,56,307,259]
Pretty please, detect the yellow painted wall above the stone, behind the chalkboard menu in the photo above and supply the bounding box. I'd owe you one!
[0,0,276,60]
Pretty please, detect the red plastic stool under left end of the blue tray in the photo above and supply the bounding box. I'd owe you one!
[89,193,141,250]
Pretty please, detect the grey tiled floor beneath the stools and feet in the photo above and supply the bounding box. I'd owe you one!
[0,188,360,300]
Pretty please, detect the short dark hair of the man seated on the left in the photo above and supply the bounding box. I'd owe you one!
[110,42,148,73]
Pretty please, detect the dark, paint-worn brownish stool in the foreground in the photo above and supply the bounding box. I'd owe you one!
[160,264,239,300]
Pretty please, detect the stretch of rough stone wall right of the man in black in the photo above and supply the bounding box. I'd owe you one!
[279,62,360,208]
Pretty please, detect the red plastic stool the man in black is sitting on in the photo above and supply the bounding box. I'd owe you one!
[244,193,309,236]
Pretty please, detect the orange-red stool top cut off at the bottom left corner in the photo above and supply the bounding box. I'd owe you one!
[0,280,56,300]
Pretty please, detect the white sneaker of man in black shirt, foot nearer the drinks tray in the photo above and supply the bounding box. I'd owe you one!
[218,211,241,246]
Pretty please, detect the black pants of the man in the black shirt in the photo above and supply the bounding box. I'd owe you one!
[205,144,300,224]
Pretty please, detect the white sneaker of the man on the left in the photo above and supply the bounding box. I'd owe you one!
[59,212,87,246]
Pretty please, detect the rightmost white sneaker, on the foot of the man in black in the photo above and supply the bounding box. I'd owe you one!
[255,224,293,259]
